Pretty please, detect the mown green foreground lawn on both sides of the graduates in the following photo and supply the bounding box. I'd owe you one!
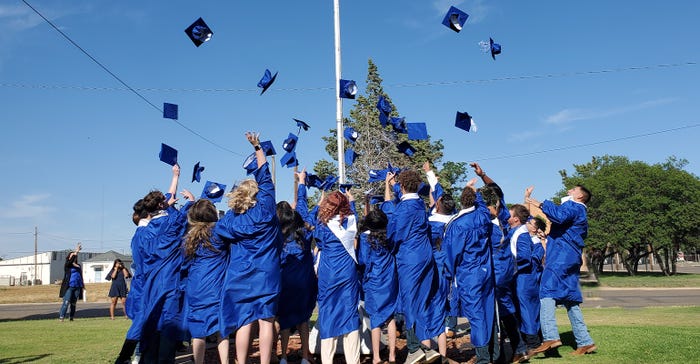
[0,307,700,364]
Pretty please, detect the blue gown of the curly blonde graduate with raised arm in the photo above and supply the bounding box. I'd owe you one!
[214,162,282,335]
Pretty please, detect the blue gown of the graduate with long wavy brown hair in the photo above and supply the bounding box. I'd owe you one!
[185,236,228,338]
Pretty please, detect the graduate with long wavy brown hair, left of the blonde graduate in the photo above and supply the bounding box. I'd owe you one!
[183,199,229,364]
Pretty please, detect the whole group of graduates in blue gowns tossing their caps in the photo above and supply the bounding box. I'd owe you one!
[116,133,597,364]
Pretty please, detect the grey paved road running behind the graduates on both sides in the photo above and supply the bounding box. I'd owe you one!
[0,288,700,321]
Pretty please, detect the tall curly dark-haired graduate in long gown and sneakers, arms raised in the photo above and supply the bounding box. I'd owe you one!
[382,170,445,364]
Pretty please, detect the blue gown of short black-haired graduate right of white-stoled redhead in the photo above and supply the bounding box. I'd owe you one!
[357,233,399,329]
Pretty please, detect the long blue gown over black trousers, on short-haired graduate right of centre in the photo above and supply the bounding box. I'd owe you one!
[444,195,495,347]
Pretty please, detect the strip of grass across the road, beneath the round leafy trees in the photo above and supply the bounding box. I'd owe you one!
[598,272,700,288]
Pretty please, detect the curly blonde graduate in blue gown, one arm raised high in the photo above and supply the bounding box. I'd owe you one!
[214,132,282,364]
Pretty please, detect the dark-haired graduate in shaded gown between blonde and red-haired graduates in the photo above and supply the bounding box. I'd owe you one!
[277,169,318,364]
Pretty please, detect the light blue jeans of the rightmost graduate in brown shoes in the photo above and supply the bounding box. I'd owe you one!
[540,298,593,347]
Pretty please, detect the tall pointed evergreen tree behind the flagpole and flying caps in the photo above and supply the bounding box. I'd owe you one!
[314,59,466,209]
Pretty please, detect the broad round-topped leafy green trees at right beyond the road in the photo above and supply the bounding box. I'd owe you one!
[558,155,700,275]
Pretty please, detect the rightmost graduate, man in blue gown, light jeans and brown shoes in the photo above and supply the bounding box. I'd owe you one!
[525,185,598,355]
